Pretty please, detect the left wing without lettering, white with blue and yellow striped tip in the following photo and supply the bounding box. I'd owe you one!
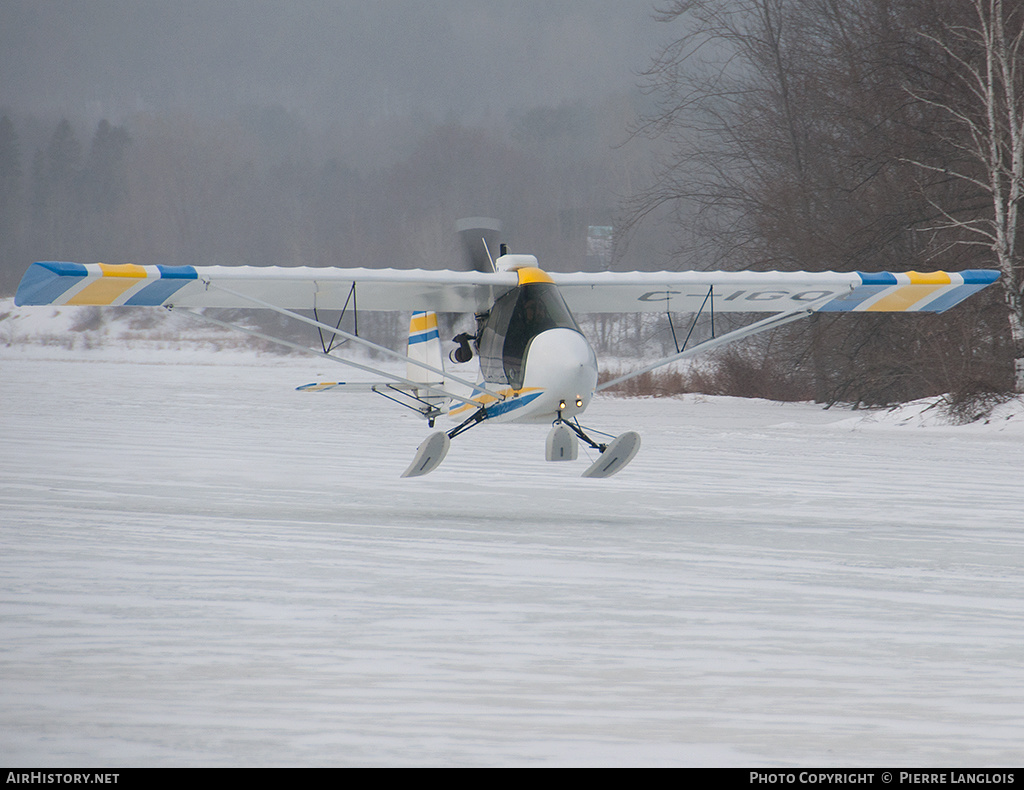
[14,261,518,313]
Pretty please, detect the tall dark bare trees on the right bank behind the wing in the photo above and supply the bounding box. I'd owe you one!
[632,0,1024,405]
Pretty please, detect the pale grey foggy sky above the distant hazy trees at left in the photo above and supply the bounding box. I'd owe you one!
[0,0,669,123]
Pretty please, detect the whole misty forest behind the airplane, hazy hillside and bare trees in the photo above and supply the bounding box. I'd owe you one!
[0,0,1024,406]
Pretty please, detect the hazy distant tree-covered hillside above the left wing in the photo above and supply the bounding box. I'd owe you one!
[0,97,651,293]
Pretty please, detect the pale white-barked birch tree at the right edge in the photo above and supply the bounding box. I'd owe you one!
[915,0,1024,392]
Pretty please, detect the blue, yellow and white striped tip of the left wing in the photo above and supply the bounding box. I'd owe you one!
[14,260,199,306]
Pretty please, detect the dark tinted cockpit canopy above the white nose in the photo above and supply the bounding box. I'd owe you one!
[478,283,580,389]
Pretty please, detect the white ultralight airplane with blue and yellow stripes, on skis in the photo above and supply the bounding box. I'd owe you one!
[14,217,998,477]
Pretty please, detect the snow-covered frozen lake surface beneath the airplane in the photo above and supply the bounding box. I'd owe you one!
[0,348,1024,766]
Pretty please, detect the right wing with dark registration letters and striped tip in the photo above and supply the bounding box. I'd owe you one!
[551,269,999,313]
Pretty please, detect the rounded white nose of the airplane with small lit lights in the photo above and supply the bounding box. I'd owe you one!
[523,329,597,421]
